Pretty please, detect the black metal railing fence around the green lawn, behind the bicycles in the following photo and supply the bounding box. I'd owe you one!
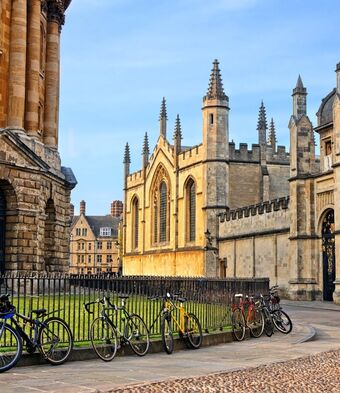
[0,274,269,342]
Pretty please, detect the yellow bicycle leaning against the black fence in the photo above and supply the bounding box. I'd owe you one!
[150,292,203,355]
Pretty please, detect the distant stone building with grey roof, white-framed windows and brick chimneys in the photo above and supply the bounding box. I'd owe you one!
[70,201,122,274]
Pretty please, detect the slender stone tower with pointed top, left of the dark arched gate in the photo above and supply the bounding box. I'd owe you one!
[289,76,317,300]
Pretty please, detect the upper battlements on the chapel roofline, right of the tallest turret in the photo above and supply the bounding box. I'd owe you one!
[229,142,289,164]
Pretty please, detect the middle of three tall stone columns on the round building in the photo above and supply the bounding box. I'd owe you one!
[25,0,41,138]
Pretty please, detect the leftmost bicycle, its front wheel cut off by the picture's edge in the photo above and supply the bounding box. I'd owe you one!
[0,294,73,372]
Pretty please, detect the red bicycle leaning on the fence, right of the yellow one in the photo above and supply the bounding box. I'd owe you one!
[231,293,264,341]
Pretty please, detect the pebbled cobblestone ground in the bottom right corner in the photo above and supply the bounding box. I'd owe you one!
[110,350,340,393]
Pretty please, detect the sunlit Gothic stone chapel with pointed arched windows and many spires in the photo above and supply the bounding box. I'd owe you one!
[123,60,290,276]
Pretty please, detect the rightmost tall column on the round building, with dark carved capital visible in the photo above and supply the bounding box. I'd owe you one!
[44,2,64,149]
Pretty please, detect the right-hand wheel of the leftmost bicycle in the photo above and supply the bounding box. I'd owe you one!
[38,317,73,366]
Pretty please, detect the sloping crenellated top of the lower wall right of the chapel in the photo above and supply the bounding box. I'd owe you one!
[218,196,289,222]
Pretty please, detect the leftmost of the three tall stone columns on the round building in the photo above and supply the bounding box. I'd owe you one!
[7,0,27,129]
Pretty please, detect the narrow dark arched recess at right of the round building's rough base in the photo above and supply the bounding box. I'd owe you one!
[44,199,56,273]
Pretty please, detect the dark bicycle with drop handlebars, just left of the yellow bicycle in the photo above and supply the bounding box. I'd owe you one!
[84,295,150,362]
